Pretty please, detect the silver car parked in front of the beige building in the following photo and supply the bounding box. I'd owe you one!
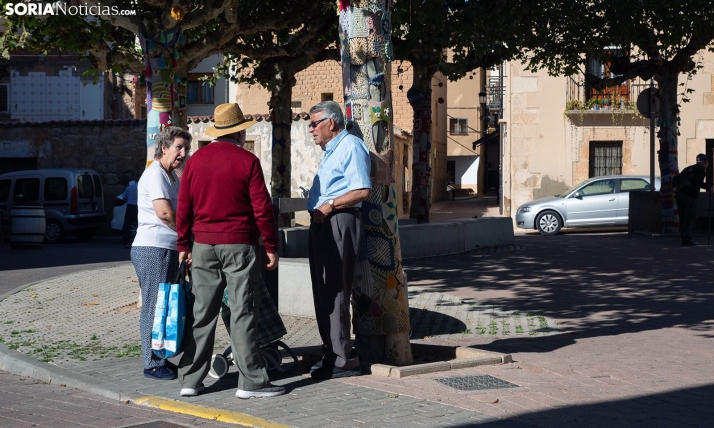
[516,175,660,235]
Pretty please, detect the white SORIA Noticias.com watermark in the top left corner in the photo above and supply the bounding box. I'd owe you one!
[3,0,138,16]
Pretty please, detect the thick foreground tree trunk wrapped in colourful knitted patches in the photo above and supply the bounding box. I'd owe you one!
[340,0,413,365]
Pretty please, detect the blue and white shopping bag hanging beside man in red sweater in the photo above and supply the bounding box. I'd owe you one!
[151,262,191,358]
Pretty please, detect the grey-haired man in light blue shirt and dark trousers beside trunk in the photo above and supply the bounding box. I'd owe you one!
[307,101,372,379]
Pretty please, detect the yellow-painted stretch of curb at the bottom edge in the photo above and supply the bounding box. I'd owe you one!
[132,396,291,428]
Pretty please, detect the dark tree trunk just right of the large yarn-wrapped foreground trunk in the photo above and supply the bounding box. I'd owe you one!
[407,62,434,223]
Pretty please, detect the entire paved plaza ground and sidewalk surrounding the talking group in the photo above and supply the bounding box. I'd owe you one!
[0,232,714,427]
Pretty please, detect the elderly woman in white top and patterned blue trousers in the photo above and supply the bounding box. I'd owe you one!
[131,126,191,380]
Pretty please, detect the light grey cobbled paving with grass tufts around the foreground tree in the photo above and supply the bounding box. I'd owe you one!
[0,247,555,365]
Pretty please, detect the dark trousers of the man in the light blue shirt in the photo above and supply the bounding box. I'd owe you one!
[308,210,362,369]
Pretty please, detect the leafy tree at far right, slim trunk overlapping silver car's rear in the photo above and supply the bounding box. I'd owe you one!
[519,0,714,233]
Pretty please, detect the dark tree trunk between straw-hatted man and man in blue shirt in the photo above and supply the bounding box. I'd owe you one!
[268,63,295,227]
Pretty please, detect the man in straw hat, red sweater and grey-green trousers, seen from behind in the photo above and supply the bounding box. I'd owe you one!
[176,104,285,398]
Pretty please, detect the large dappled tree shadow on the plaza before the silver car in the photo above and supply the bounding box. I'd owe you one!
[409,234,714,353]
